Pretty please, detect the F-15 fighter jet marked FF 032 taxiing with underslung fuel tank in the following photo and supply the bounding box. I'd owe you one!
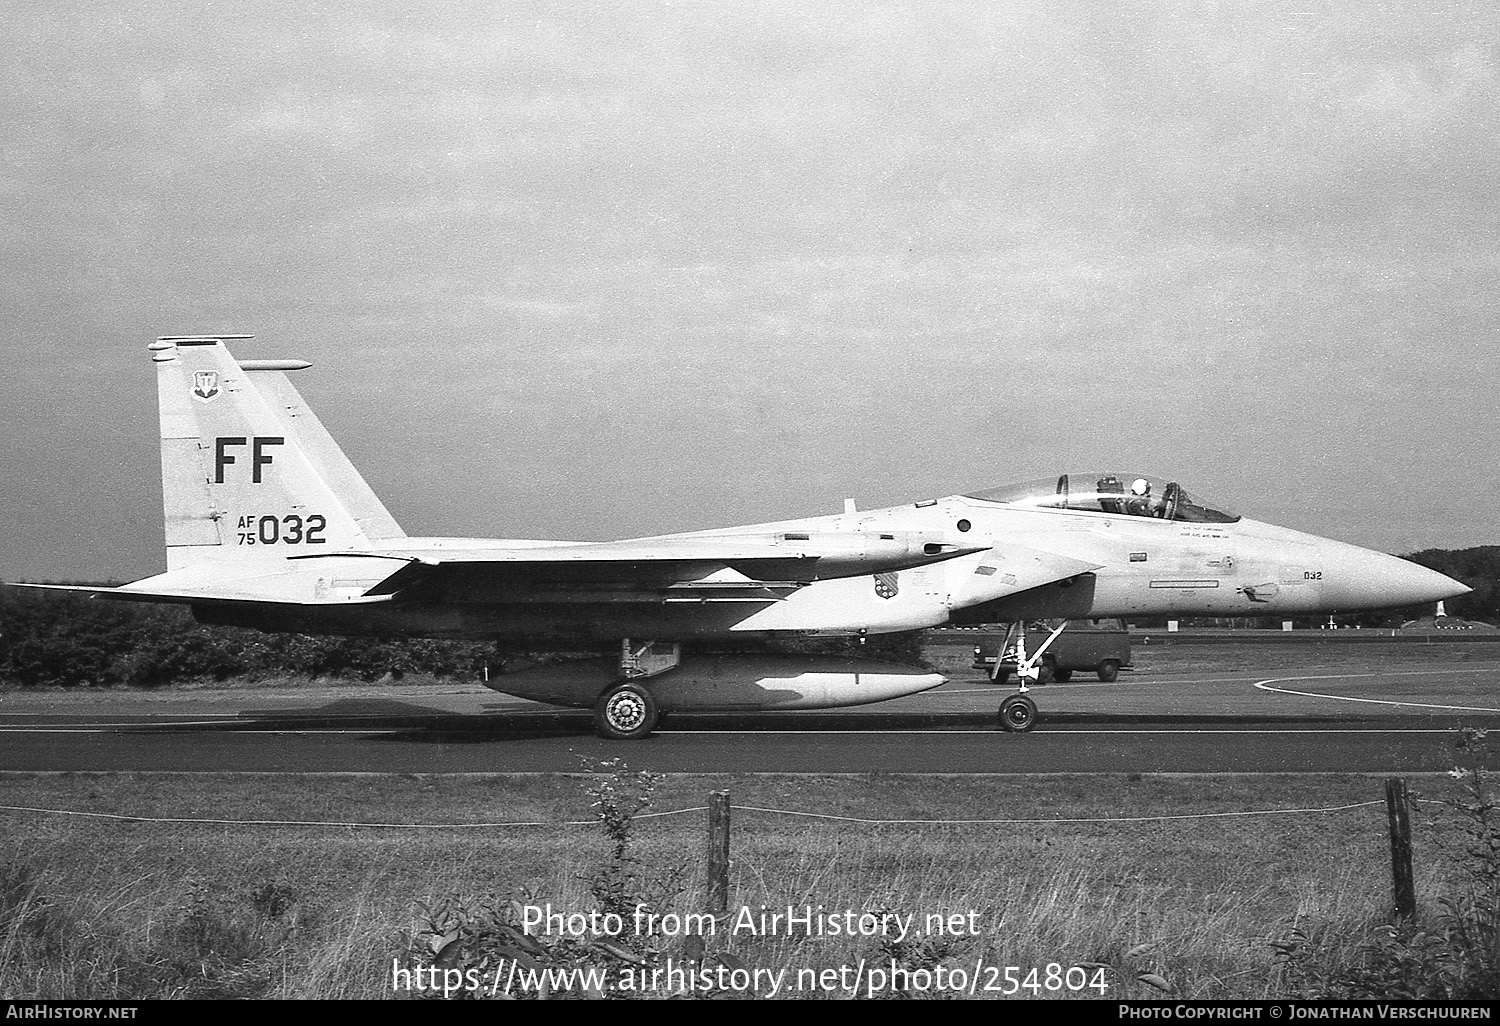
[11,335,1469,738]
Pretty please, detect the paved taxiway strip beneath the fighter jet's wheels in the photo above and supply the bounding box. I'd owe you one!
[0,657,1500,774]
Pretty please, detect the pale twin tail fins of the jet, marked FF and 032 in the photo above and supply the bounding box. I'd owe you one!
[150,335,405,570]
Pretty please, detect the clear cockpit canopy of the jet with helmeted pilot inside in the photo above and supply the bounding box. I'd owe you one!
[969,473,1239,524]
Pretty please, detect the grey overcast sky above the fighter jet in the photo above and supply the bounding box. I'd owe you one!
[0,0,1500,581]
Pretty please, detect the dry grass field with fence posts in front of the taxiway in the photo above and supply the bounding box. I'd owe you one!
[0,774,1494,999]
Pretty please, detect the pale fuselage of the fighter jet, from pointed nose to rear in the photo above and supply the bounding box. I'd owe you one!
[195,495,1454,642]
